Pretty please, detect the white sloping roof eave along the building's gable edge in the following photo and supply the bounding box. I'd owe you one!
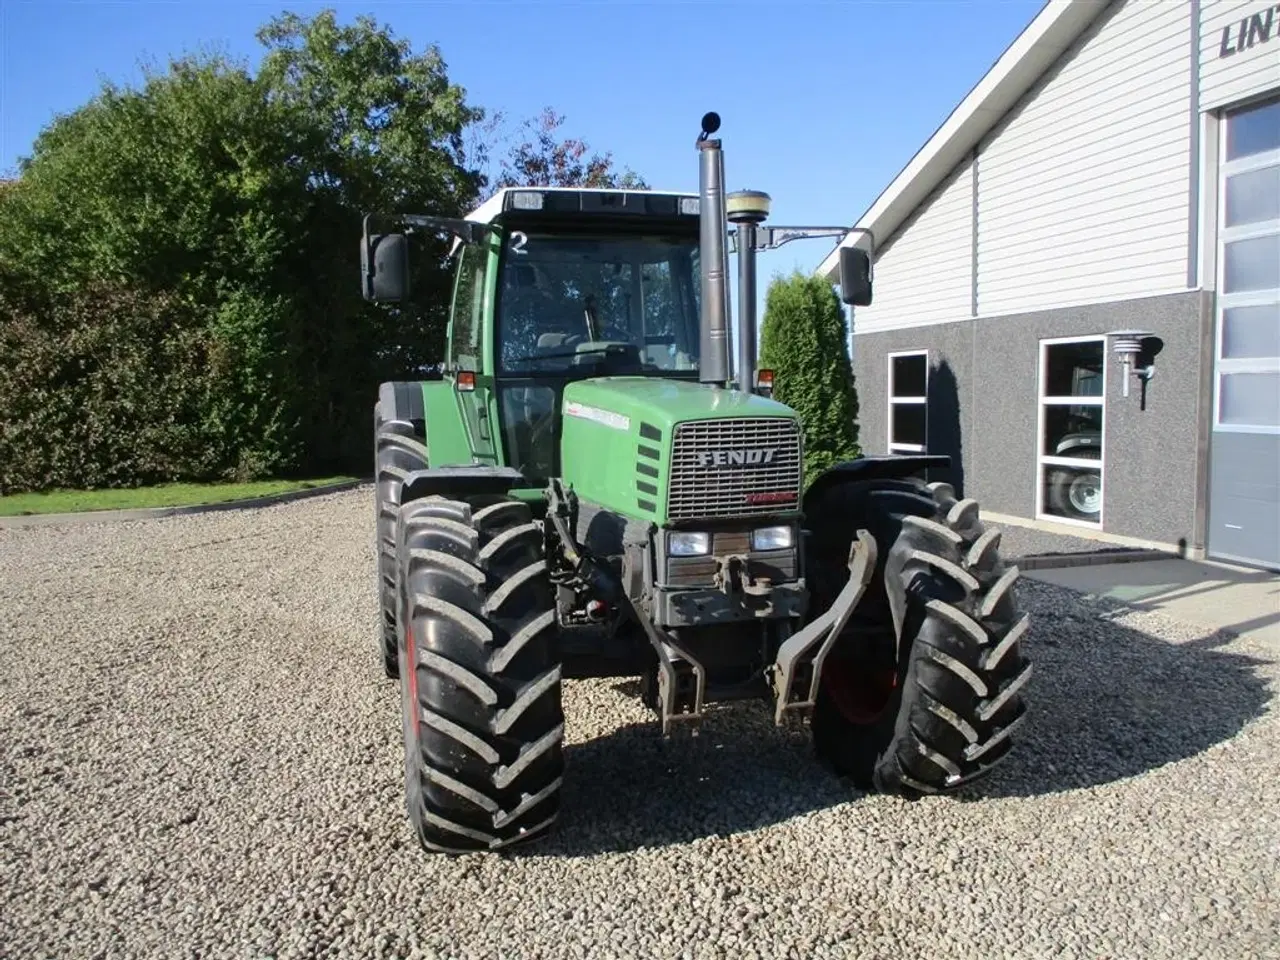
[818,0,1111,283]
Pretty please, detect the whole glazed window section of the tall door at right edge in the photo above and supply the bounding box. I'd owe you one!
[1213,100,1280,434]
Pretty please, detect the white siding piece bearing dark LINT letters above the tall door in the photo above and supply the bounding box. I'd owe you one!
[1199,0,1280,110]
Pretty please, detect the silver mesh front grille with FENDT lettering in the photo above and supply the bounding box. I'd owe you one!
[667,417,801,520]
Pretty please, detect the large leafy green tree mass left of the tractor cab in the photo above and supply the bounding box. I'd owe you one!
[0,12,483,496]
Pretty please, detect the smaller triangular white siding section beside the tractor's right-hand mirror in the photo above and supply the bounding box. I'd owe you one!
[854,163,973,334]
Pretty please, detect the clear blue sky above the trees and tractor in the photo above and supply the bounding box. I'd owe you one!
[0,0,1043,298]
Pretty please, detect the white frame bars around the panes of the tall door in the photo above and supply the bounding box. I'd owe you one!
[1213,97,1280,436]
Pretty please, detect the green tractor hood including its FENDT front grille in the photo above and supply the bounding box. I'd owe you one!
[561,376,801,525]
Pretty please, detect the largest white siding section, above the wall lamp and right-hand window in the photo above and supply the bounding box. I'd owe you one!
[972,0,1193,316]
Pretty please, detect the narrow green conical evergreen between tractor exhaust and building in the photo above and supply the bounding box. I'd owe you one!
[760,271,860,486]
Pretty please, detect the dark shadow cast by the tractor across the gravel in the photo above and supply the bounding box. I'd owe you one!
[524,581,1270,856]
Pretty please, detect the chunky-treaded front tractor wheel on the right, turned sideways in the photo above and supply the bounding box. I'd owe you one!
[806,480,1030,797]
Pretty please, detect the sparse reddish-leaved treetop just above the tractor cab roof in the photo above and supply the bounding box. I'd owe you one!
[488,106,648,189]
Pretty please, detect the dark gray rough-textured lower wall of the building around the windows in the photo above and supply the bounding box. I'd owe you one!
[854,292,1212,547]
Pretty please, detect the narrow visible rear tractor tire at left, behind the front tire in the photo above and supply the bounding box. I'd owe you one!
[374,383,426,678]
